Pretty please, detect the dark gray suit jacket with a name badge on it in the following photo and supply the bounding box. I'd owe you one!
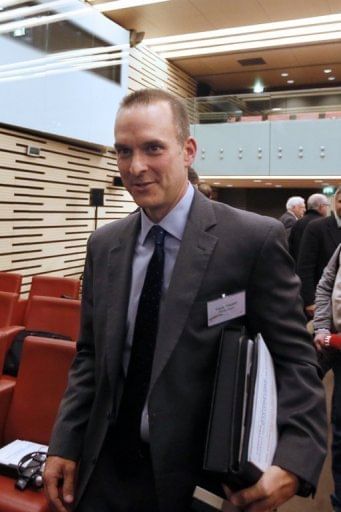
[50,193,326,512]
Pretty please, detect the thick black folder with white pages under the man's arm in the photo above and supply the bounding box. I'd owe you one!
[203,327,277,490]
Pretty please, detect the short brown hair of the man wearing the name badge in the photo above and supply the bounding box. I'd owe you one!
[119,89,190,144]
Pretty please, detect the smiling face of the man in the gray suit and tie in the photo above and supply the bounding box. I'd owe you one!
[115,101,196,222]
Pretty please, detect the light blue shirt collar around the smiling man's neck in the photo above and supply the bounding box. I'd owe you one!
[139,184,194,244]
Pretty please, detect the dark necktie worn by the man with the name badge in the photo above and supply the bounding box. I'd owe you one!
[115,226,166,463]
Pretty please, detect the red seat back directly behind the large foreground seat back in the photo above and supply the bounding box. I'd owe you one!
[24,295,80,340]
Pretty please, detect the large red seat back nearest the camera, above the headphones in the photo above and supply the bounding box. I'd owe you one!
[3,336,76,444]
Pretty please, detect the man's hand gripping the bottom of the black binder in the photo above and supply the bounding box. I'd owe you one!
[229,466,299,512]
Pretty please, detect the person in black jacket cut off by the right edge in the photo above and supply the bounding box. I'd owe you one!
[297,187,341,319]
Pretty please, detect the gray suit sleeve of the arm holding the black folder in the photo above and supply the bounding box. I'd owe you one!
[247,224,327,487]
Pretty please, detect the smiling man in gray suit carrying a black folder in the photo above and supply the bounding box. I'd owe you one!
[45,90,326,512]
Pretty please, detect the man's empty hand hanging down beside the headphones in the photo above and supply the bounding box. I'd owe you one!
[44,456,76,512]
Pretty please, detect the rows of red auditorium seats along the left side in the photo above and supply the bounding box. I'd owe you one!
[0,272,80,512]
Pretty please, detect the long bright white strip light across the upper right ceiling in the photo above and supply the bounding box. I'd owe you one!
[144,14,341,59]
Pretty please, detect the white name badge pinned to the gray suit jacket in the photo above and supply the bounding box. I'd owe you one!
[207,291,245,327]
